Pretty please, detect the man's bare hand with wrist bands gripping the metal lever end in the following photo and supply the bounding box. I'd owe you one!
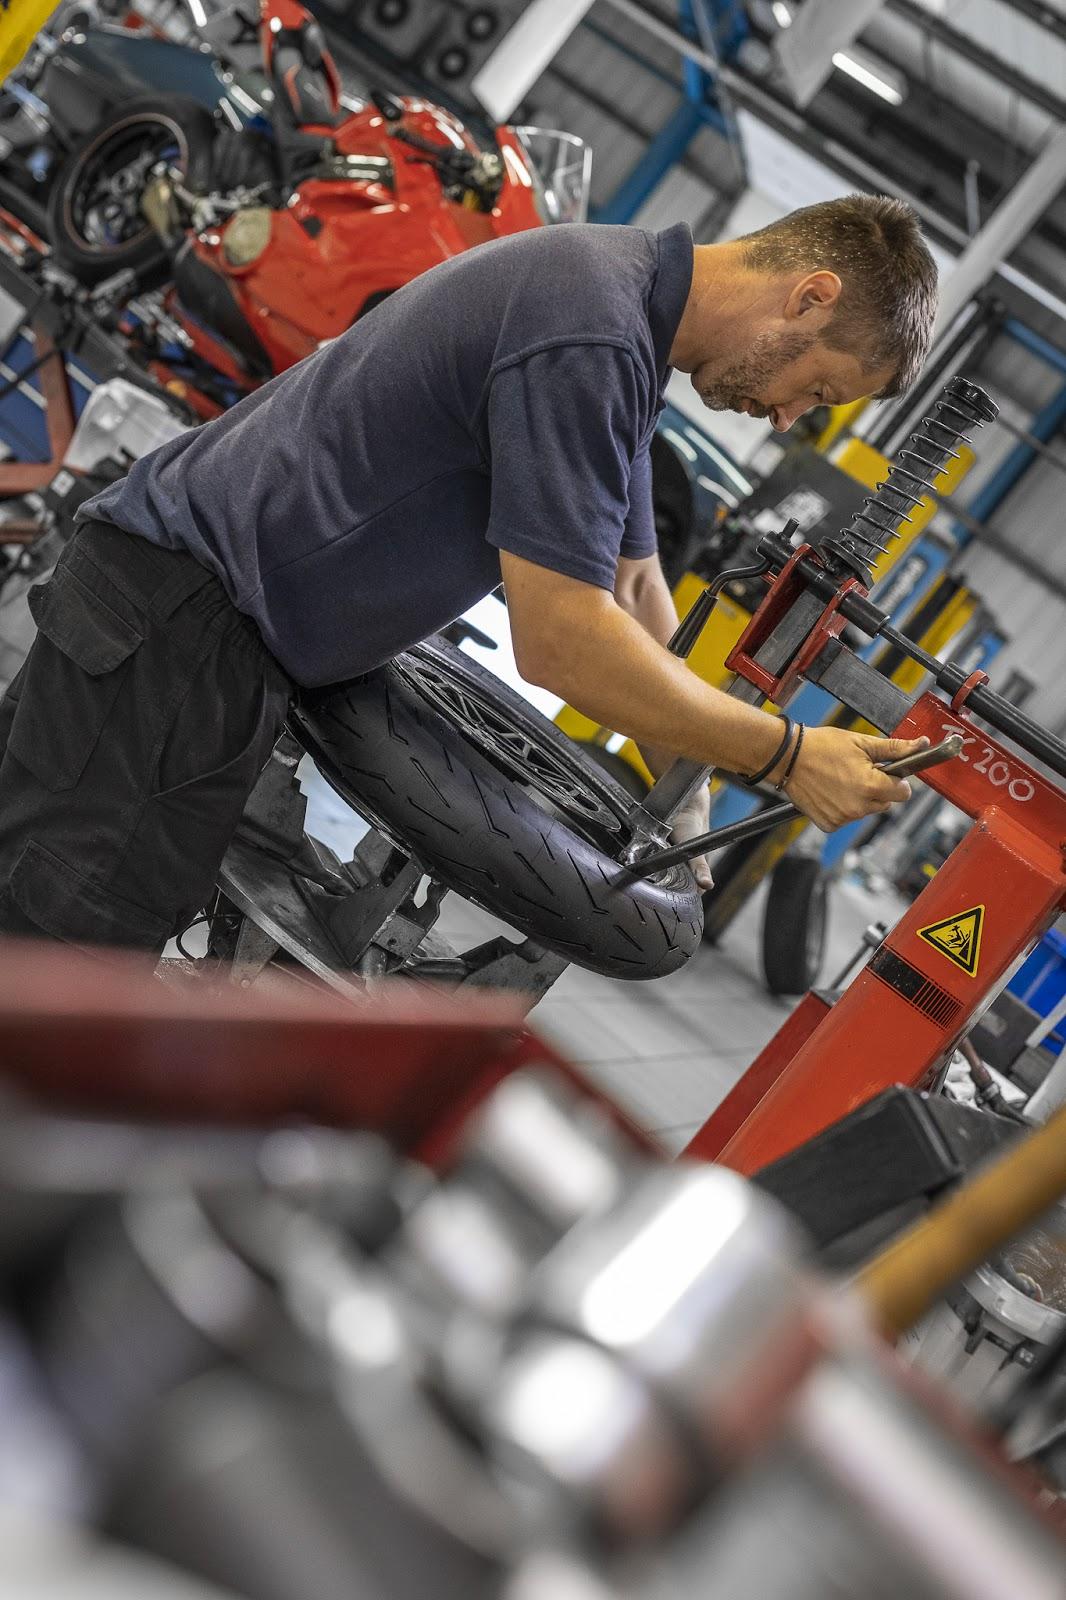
[786,728,928,834]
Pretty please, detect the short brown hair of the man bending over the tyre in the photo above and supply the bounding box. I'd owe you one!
[738,195,936,398]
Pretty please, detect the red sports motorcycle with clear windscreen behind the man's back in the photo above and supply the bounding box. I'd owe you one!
[54,0,587,418]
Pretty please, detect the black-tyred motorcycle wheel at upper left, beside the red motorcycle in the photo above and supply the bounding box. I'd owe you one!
[48,94,216,283]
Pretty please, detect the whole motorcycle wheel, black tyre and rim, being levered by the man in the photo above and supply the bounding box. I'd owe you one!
[293,640,703,978]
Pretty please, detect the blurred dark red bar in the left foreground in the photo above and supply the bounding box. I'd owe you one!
[0,941,541,1154]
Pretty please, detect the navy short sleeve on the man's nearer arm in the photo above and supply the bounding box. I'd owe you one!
[487,344,650,589]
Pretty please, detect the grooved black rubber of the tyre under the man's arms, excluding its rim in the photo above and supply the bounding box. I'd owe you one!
[293,640,703,979]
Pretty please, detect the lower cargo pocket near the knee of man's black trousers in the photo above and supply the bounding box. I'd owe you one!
[8,842,171,950]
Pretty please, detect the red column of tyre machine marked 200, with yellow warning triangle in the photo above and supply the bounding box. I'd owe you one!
[685,694,1066,1173]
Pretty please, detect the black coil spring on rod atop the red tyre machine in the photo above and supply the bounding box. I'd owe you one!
[821,378,999,578]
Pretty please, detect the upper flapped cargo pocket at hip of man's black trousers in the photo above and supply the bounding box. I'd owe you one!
[8,566,142,790]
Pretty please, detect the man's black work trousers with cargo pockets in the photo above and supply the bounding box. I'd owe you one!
[0,522,293,950]
